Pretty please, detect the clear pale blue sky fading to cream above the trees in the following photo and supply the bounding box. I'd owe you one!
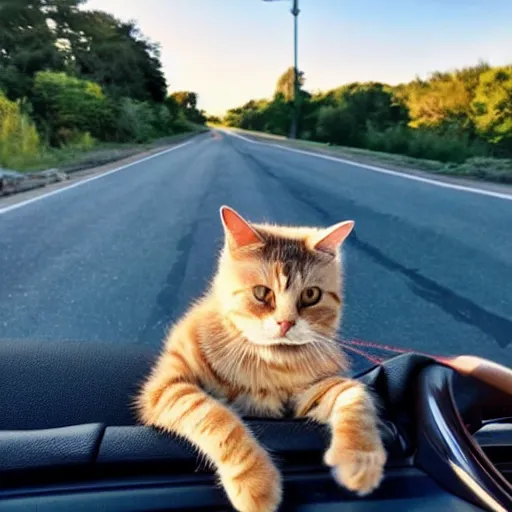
[86,0,512,114]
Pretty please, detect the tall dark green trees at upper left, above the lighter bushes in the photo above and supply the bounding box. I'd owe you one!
[0,0,167,102]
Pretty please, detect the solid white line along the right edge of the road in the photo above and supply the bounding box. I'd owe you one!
[221,130,512,201]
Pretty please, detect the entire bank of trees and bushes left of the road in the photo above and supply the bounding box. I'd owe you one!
[0,0,206,166]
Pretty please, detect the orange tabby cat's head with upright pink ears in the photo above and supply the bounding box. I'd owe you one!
[214,206,354,346]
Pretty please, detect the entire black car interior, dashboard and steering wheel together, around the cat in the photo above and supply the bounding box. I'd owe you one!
[0,341,512,512]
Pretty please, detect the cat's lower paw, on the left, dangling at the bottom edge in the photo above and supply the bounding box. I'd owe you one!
[220,449,282,512]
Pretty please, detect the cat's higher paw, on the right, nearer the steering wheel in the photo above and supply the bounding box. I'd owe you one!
[324,443,387,496]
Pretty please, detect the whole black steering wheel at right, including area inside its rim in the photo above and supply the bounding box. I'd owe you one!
[415,356,512,512]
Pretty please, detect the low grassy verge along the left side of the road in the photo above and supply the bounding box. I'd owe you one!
[9,123,209,172]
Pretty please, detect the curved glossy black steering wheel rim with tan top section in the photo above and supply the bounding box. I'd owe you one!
[416,358,512,512]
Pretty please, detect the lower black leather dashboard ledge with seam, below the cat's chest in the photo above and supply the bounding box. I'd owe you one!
[0,420,494,512]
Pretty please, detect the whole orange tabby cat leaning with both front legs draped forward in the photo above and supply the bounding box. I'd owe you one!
[137,207,386,512]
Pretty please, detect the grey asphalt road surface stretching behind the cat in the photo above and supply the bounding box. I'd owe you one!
[0,134,512,372]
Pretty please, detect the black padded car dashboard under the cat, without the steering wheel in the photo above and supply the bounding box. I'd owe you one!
[0,343,512,512]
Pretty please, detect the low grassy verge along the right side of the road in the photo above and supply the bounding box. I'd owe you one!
[222,126,512,184]
